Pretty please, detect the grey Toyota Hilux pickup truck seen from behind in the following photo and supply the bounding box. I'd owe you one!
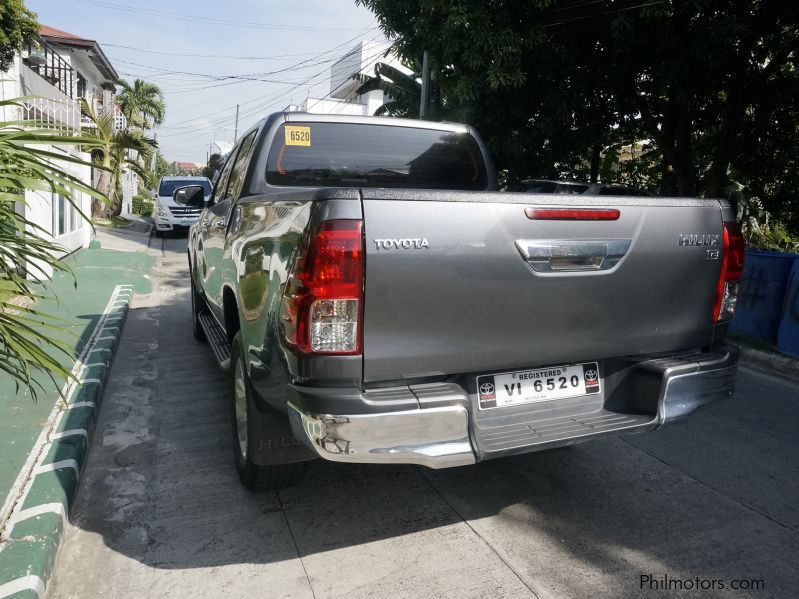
[186,113,744,488]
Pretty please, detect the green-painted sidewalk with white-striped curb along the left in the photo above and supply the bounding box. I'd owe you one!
[0,245,153,597]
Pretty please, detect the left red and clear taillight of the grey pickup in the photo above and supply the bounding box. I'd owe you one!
[280,220,366,355]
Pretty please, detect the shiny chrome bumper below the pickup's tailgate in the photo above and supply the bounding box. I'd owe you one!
[288,347,738,468]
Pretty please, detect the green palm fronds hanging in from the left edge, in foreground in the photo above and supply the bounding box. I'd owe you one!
[0,100,104,399]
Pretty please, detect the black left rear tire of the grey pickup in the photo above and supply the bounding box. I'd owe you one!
[230,333,308,491]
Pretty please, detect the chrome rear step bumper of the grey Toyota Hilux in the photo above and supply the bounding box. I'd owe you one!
[288,349,737,468]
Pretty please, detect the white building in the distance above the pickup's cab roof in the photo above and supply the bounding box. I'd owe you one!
[286,40,410,116]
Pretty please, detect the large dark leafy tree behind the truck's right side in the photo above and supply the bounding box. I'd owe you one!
[356,0,799,218]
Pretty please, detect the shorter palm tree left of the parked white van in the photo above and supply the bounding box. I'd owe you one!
[83,100,158,216]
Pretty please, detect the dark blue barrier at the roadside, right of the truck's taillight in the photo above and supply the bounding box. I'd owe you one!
[731,251,799,356]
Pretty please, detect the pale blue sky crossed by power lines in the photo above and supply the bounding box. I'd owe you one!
[25,0,383,163]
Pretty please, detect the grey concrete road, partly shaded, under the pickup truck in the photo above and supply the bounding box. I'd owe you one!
[49,233,799,599]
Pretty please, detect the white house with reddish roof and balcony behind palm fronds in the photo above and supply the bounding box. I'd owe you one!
[0,25,126,276]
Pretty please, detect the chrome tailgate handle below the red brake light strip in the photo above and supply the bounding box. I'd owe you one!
[516,239,632,272]
